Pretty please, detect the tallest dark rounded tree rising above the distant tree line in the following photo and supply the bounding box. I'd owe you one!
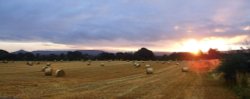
[134,48,155,60]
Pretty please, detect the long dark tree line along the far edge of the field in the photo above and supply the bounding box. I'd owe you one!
[0,48,225,61]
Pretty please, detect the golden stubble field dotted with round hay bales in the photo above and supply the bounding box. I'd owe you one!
[0,61,237,99]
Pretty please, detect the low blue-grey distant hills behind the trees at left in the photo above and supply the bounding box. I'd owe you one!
[12,50,104,55]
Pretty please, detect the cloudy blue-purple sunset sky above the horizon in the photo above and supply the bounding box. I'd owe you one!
[0,0,250,52]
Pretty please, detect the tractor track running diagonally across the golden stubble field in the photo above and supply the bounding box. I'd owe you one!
[41,63,176,97]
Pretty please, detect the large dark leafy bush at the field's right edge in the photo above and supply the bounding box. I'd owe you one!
[217,48,250,99]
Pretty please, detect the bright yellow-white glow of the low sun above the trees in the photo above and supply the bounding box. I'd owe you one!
[177,35,249,54]
